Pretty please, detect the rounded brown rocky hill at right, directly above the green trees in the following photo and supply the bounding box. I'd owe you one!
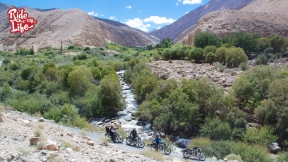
[182,0,288,45]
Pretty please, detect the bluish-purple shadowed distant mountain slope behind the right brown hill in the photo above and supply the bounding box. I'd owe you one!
[150,0,252,40]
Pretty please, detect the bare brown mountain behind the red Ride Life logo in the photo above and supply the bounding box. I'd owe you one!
[0,3,157,50]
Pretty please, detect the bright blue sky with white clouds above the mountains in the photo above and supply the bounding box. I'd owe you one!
[0,0,210,32]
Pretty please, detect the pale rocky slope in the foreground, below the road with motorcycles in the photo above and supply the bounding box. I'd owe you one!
[0,106,184,162]
